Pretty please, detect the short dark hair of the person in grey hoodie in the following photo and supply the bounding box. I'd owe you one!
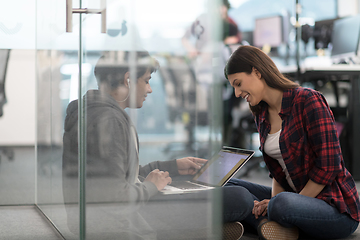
[94,51,160,89]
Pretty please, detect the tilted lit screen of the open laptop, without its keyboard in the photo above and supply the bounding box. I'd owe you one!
[193,147,254,186]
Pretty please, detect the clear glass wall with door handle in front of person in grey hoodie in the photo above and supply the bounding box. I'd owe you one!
[36,0,223,239]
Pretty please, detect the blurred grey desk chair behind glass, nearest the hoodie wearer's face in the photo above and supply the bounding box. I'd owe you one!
[159,56,209,158]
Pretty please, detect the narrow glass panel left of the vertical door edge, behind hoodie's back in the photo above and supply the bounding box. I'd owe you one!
[36,0,80,239]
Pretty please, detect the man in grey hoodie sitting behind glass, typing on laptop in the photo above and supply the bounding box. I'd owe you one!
[63,52,211,238]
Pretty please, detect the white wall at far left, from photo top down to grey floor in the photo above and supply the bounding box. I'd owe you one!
[0,0,36,146]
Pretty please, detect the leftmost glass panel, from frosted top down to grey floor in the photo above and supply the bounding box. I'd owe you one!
[0,0,36,205]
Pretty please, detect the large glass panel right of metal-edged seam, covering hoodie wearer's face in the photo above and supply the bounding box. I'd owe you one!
[80,0,221,239]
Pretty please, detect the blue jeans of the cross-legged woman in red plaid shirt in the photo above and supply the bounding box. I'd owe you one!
[225,179,359,239]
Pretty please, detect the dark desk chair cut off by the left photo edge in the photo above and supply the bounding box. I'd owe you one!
[0,49,14,160]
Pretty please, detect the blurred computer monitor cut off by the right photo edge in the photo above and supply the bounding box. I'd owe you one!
[331,14,360,63]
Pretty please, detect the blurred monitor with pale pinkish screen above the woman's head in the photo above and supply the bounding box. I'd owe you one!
[253,15,284,47]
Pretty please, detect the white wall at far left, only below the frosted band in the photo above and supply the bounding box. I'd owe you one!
[0,50,36,146]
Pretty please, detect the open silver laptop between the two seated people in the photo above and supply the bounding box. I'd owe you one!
[160,147,255,194]
